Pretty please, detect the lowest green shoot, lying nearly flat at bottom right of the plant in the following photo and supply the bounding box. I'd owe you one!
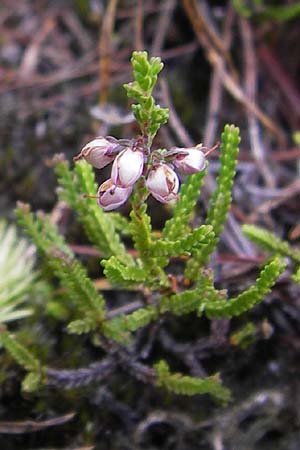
[154,361,230,403]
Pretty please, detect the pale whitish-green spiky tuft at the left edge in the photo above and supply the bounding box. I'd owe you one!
[0,221,37,324]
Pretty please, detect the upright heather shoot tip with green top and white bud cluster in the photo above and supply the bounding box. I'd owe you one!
[74,52,210,211]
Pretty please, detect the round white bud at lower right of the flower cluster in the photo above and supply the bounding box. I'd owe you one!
[146,164,179,203]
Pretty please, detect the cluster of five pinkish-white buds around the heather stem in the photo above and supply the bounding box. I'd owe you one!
[74,136,206,211]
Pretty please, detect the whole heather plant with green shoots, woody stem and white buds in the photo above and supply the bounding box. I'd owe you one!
[1,52,285,402]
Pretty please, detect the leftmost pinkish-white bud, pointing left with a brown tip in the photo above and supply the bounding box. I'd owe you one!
[74,136,118,169]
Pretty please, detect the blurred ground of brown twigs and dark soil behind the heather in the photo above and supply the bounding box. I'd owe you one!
[0,0,300,450]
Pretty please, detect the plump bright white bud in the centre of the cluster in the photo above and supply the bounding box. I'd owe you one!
[111,148,144,188]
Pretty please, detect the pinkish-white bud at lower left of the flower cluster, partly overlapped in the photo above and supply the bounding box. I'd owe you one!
[97,179,132,211]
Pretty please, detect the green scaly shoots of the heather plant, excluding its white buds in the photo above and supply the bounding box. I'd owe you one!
[1,52,284,402]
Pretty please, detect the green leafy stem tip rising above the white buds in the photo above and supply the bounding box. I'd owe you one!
[124,52,169,144]
